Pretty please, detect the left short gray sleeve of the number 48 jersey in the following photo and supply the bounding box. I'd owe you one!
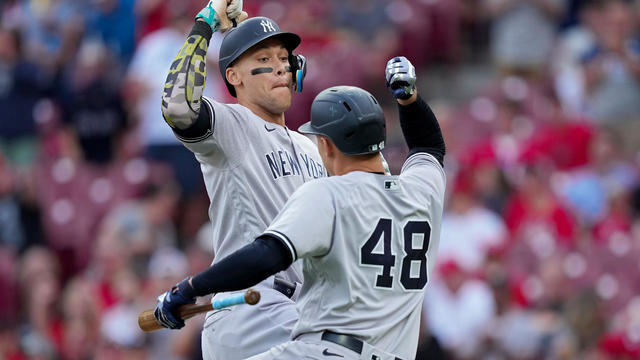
[263,180,336,260]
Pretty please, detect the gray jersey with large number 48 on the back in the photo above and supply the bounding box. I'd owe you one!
[265,153,445,359]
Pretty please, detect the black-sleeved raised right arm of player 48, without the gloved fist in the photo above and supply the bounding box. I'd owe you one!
[398,91,446,165]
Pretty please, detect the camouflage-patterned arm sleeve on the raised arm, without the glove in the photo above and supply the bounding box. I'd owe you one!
[162,21,213,137]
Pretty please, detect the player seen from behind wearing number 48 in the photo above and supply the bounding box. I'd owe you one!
[157,57,445,360]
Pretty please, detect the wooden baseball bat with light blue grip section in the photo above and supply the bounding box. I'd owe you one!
[138,289,260,332]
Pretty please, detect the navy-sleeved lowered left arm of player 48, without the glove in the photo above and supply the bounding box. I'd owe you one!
[191,237,293,296]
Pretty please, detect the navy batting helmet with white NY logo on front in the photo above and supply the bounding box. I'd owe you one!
[218,16,301,97]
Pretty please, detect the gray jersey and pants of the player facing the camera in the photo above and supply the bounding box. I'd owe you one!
[180,98,326,360]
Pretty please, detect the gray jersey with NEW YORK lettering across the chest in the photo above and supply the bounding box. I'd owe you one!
[180,97,326,282]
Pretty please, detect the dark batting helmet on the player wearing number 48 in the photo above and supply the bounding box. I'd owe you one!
[298,86,386,155]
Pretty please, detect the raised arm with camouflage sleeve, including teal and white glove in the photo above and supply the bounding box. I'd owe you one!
[162,0,246,139]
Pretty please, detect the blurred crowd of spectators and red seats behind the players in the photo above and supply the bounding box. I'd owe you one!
[0,0,640,360]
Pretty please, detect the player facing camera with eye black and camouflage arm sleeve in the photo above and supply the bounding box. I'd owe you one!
[156,0,326,360]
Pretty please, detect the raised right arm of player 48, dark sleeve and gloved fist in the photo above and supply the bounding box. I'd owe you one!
[385,56,446,165]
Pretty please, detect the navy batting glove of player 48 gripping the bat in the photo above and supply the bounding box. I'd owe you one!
[153,278,196,329]
